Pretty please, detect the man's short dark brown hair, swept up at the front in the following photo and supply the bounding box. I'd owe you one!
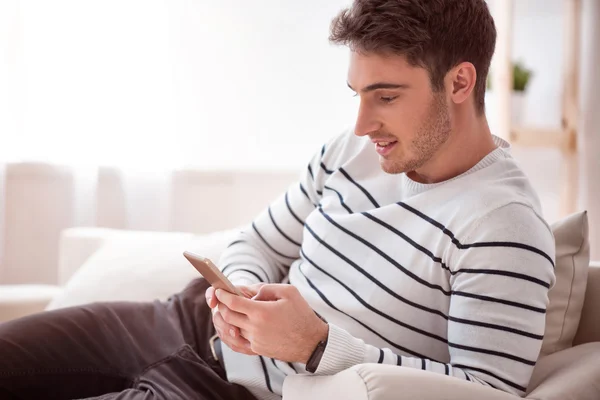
[329,0,496,114]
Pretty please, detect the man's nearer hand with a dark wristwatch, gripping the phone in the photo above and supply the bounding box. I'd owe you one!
[214,284,329,364]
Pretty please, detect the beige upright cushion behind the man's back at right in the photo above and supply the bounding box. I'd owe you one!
[540,212,590,356]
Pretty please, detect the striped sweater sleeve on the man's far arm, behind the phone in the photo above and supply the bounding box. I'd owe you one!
[219,144,331,285]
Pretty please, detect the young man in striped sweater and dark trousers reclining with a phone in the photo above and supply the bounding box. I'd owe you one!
[0,0,554,399]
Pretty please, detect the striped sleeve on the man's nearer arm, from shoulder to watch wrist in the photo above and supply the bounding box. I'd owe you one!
[316,203,555,396]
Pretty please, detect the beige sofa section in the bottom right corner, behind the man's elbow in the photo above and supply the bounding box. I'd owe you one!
[527,342,600,400]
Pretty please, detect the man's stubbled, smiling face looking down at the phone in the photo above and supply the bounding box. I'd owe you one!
[348,51,451,174]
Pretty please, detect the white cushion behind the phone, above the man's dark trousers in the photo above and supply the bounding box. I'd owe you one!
[46,230,238,310]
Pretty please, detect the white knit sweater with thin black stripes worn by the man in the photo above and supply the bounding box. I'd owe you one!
[219,132,555,399]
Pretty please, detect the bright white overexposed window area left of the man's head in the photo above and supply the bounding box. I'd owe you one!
[0,0,356,170]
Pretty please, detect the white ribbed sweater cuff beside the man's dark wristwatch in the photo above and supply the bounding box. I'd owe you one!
[315,323,365,375]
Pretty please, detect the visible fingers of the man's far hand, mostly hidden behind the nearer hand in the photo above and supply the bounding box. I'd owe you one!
[205,283,263,355]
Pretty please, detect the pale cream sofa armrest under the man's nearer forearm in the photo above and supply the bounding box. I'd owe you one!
[283,364,518,400]
